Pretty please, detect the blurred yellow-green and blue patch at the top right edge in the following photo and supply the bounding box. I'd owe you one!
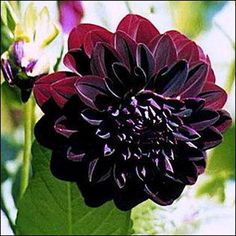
[169,1,227,38]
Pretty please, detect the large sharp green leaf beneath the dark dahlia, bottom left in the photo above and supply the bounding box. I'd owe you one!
[16,142,131,235]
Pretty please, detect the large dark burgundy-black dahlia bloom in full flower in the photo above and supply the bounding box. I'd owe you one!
[33,15,231,210]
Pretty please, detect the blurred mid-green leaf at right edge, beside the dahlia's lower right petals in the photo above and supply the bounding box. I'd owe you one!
[206,126,235,178]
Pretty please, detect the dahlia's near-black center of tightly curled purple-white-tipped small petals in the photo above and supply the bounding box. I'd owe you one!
[101,93,179,159]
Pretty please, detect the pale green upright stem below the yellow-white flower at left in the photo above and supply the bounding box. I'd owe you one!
[20,97,34,198]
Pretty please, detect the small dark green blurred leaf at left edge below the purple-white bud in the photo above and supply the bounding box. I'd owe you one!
[1,81,22,109]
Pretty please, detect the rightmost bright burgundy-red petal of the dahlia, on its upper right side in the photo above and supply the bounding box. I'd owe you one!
[199,82,227,110]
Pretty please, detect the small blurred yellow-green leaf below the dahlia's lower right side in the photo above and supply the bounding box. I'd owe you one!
[196,176,225,202]
